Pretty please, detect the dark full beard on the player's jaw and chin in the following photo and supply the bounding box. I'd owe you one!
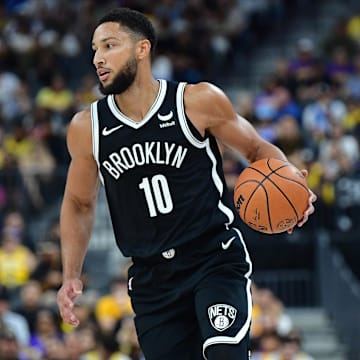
[99,57,137,95]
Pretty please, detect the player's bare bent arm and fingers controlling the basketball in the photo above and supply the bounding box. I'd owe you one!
[184,82,316,231]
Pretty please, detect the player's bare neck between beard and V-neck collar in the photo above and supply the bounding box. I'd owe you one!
[115,77,160,121]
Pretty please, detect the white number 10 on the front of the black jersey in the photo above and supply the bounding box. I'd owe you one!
[139,174,174,217]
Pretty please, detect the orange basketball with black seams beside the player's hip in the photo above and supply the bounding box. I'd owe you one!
[234,158,309,234]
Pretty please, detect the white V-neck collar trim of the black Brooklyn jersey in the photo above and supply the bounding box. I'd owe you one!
[107,80,167,129]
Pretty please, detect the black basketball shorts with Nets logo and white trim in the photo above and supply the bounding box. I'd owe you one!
[129,229,252,360]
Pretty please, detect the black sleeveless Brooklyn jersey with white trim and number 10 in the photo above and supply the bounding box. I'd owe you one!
[91,80,243,257]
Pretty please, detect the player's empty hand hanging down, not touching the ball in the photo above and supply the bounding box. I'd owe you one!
[57,279,83,327]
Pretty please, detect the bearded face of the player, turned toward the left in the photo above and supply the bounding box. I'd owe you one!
[92,22,137,95]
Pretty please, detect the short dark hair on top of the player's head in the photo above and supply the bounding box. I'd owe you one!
[96,7,157,54]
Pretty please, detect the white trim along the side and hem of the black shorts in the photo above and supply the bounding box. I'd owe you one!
[203,228,252,359]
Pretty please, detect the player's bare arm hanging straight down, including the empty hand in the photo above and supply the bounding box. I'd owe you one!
[57,110,99,326]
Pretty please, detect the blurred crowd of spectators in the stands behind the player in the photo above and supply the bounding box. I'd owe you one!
[0,0,360,360]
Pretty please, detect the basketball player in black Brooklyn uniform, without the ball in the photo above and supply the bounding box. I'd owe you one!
[58,8,315,360]
